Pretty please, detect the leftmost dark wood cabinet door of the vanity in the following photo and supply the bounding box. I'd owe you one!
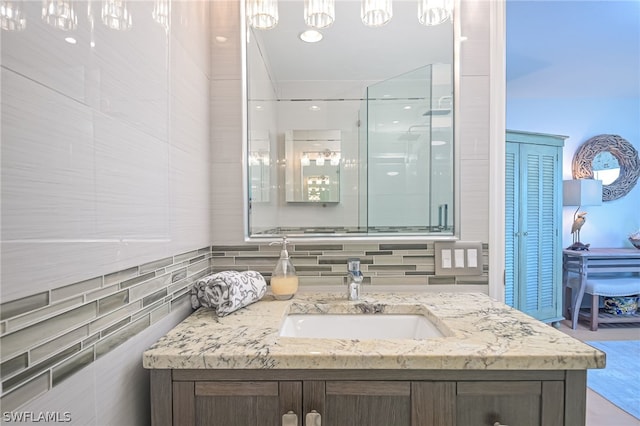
[173,381,302,426]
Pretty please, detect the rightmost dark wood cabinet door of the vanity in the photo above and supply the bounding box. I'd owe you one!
[456,381,564,426]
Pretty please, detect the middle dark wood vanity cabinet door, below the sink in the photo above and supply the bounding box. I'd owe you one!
[304,381,411,426]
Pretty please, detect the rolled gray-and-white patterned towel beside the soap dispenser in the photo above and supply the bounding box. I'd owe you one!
[191,271,267,317]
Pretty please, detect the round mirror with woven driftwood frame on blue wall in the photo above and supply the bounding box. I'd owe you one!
[572,135,640,201]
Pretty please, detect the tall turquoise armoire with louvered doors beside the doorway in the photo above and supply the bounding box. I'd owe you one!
[505,138,562,321]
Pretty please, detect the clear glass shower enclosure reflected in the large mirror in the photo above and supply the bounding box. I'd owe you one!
[360,64,454,235]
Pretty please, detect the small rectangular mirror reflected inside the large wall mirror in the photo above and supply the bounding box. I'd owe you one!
[285,130,341,203]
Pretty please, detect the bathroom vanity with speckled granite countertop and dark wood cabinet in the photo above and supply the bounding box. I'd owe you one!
[143,293,605,426]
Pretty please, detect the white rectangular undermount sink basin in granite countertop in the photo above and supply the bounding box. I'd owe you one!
[280,314,444,339]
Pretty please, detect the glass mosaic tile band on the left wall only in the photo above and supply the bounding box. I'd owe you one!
[0,247,211,411]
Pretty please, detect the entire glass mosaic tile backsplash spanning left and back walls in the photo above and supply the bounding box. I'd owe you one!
[0,242,488,411]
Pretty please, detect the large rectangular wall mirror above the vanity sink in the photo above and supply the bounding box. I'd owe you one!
[245,0,456,238]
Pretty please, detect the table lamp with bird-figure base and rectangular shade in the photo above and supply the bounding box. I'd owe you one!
[562,179,602,250]
